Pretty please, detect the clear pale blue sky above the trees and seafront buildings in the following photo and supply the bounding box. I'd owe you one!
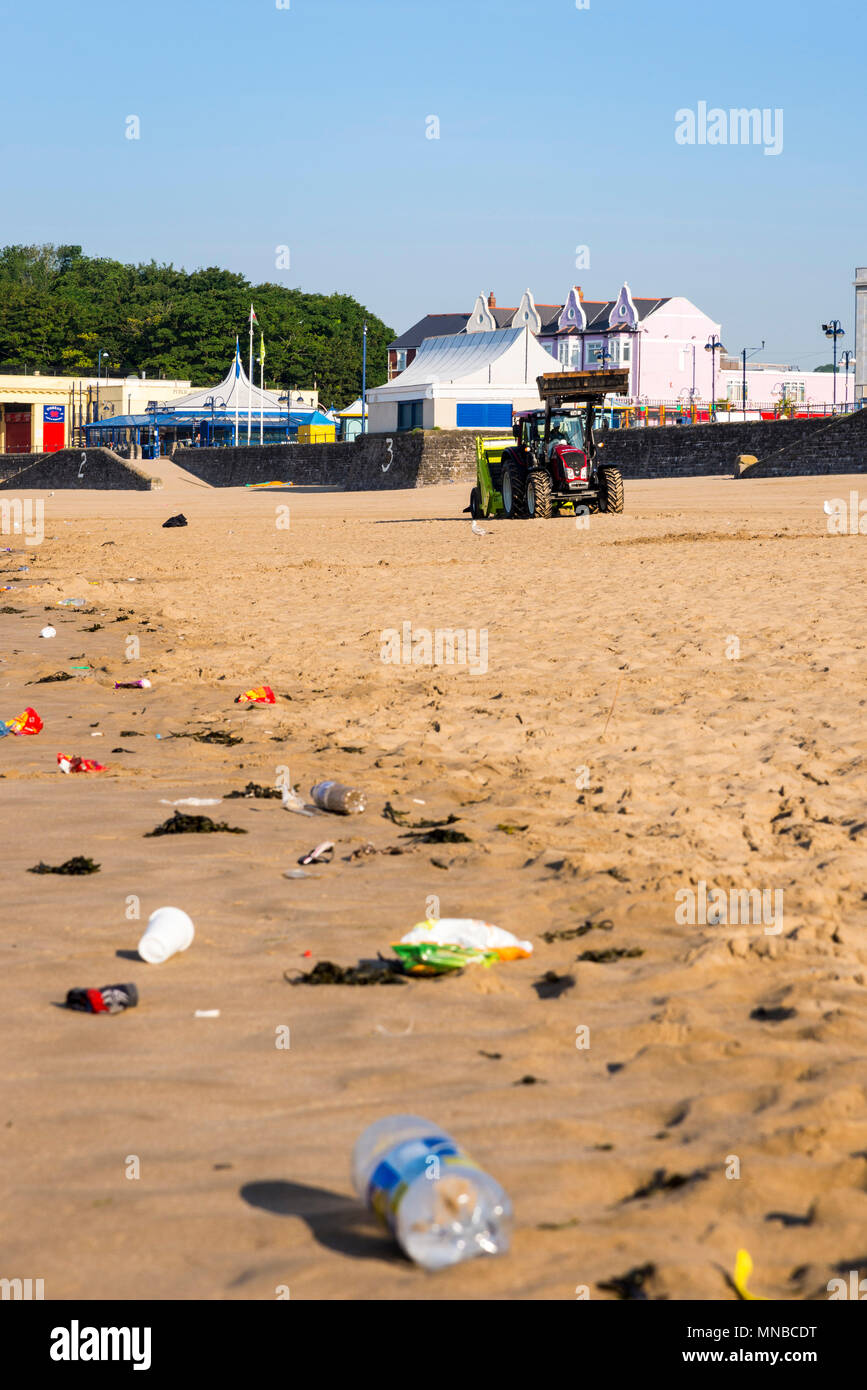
[0,0,867,368]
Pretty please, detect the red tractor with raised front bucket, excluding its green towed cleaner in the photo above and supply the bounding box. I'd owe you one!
[495,371,629,518]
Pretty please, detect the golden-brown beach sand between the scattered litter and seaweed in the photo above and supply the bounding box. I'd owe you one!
[0,466,867,1300]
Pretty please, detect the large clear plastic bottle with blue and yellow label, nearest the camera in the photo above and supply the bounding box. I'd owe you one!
[353,1115,511,1269]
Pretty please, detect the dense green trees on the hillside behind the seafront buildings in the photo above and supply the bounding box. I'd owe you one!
[0,246,395,409]
